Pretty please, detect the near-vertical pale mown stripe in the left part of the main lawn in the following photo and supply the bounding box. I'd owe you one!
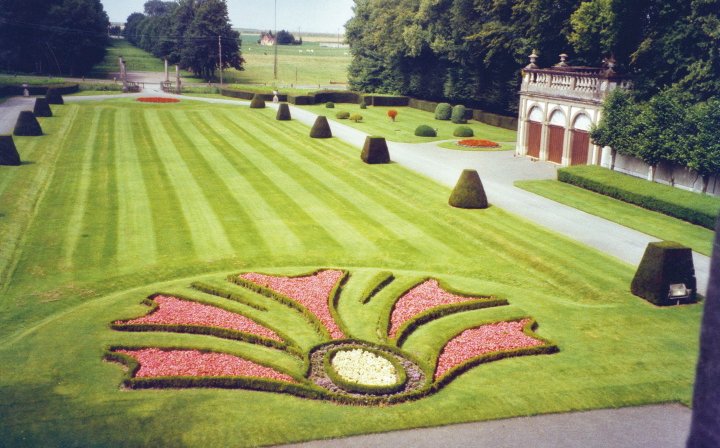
[113,109,157,270]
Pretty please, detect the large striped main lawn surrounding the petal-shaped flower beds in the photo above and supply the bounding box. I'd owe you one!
[0,99,702,446]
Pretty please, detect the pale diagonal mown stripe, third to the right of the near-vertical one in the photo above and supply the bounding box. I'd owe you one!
[208,113,377,253]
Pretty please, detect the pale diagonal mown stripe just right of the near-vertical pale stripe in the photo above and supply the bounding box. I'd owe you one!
[145,109,233,260]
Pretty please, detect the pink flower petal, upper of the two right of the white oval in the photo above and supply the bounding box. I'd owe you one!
[390,279,490,338]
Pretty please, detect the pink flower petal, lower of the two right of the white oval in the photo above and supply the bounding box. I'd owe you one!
[435,319,544,379]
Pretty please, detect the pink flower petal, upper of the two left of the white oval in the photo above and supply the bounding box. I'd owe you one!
[116,296,282,342]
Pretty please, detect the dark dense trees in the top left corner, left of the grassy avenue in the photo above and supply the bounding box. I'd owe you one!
[0,0,110,76]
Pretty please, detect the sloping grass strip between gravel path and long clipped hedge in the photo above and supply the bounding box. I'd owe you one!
[515,180,715,256]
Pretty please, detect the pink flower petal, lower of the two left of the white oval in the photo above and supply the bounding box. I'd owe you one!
[117,348,295,383]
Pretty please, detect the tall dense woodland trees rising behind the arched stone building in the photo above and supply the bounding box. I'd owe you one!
[346,0,720,113]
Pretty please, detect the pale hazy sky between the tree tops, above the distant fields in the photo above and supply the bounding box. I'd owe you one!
[101,0,353,33]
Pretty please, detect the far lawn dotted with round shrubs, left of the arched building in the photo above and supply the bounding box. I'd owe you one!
[302,103,517,143]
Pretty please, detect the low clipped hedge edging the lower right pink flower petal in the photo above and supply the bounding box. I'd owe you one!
[431,317,560,392]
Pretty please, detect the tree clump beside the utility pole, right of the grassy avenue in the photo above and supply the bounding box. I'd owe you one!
[123,0,245,80]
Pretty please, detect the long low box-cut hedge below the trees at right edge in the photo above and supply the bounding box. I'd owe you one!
[558,165,720,230]
